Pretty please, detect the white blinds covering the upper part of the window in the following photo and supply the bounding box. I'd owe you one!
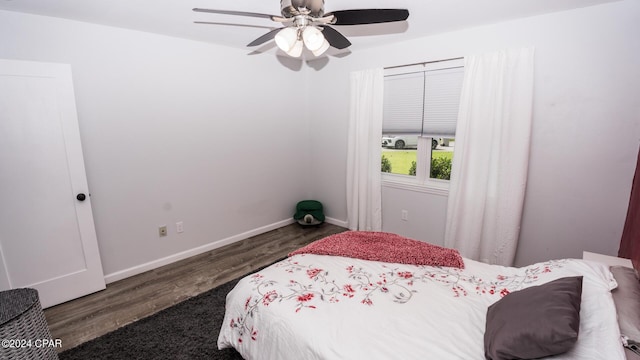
[382,67,464,137]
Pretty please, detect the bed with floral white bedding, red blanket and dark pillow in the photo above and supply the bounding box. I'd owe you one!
[218,232,638,360]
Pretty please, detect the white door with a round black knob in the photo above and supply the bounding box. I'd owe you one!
[0,60,105,307]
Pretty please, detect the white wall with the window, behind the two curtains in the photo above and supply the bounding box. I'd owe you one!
[310,0,640,265]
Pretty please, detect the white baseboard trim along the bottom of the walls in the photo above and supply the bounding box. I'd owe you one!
[104,219,296,284]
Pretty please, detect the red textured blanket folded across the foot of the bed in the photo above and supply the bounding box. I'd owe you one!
[289,231,464,269]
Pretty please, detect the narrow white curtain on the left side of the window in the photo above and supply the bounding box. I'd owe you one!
[347,69,384,231]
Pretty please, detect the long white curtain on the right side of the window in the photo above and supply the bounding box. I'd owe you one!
[445,48,534,266]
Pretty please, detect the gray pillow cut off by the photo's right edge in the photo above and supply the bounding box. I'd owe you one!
[610,266,640,360]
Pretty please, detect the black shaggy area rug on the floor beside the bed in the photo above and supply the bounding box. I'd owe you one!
[59,272,255,360]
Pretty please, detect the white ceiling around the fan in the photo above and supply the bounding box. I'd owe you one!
[0,0,618,54]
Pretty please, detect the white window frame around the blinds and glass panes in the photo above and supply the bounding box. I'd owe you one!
[380,59,464,196]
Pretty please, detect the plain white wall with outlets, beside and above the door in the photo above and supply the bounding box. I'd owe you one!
[0,11,310,280]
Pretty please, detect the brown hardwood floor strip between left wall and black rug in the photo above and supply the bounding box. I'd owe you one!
[45,223,346,351]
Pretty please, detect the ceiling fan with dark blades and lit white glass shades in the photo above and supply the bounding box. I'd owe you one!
[193,0,409,57]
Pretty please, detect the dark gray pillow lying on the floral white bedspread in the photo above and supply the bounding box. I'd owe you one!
[484,276,582,360]
